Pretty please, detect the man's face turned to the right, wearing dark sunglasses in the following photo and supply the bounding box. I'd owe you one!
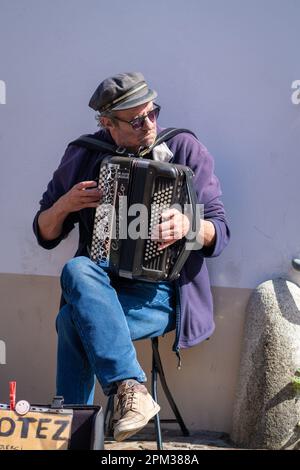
[104,101,157,151]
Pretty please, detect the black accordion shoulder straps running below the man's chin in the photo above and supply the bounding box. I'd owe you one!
[69,127,197,157]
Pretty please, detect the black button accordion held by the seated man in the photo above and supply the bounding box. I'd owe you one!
[90,156,196,282]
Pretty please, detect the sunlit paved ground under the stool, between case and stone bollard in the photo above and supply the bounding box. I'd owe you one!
[105,426,237,450]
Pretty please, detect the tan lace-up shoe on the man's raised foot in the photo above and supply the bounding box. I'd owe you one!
[114,380,160,441]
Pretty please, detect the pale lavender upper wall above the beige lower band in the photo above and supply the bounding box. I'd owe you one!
[0,0,300,288]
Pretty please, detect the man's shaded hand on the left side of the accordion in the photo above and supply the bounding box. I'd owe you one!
[57,181,100,213]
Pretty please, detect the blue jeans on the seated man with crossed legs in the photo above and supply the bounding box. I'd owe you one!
[56,256,176,404]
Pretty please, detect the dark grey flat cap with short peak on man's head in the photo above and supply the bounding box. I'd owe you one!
[89,72,157,113]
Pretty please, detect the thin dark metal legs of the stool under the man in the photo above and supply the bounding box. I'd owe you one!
[104,337,190,450]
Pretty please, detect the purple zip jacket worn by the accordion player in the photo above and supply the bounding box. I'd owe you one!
[33,128,230,350]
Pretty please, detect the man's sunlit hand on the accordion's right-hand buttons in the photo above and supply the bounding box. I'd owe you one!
[151,209,190,250]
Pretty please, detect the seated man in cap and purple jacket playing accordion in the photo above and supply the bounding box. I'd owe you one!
[34,73,229,441]
